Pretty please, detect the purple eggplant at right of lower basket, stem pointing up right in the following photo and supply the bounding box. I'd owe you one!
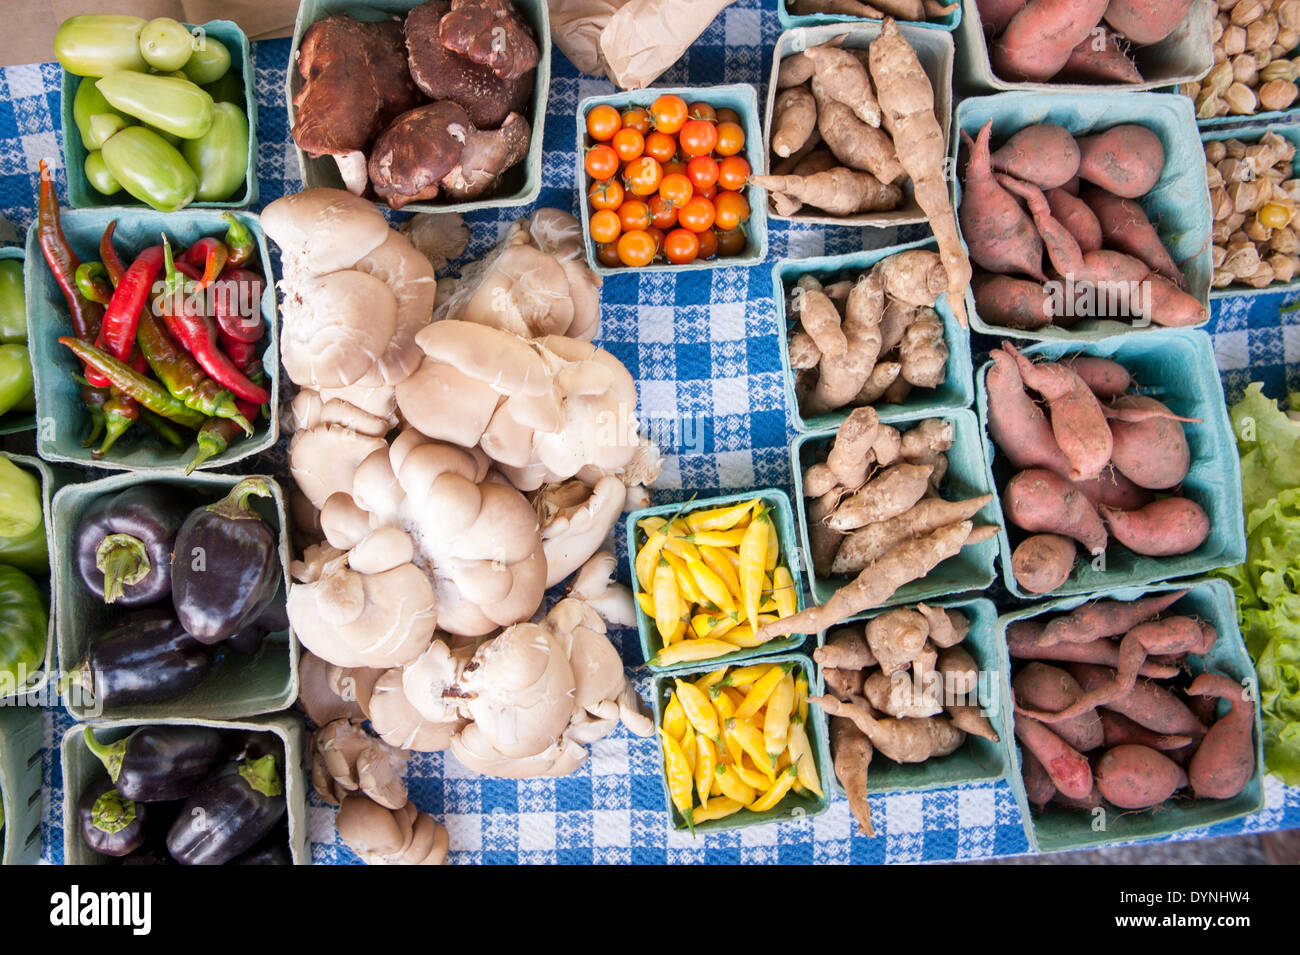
[166,752,286,865]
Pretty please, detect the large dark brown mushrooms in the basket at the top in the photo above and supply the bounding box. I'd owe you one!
[291,0,540,209]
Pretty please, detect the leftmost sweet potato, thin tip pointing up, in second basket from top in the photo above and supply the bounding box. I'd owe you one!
[959,121,1045,282]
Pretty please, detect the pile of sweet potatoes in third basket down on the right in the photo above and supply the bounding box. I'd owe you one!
[985,342,1210,594]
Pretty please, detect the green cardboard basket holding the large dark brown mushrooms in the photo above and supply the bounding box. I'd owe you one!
[285,0,551,213]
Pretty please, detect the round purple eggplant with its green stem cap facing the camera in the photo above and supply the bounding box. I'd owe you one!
[74,485,194,607]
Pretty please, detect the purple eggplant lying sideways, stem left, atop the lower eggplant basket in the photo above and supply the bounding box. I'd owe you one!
[85,726,226,803]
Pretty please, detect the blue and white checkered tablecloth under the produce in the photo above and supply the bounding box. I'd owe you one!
[0,0,1300,864]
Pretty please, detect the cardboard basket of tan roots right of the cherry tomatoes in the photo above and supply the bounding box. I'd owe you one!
[754,24,956,229]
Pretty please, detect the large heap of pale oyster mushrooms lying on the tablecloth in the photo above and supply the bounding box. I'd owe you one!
[263,190,660,864]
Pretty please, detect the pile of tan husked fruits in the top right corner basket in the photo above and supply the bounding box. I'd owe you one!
[1178,0,1300,120]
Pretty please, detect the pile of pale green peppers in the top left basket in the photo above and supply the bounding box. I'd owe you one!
[55,14,251,212]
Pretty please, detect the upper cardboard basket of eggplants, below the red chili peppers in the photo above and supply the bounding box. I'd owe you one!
[51,473,298,721]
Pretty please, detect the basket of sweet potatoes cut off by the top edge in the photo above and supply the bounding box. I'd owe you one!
[957,0,1218,96]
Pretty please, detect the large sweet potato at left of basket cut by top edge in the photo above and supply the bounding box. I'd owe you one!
[991,0,1108,83]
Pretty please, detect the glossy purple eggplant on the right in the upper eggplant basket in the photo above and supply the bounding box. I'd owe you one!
[172,477,283,644]
